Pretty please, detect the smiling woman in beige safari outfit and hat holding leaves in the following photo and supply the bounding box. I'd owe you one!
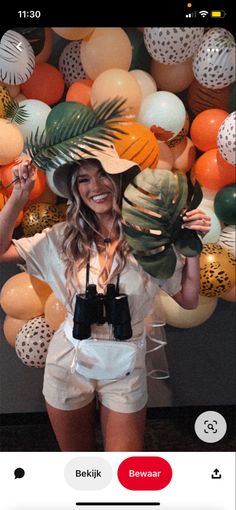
[0,151,210,451]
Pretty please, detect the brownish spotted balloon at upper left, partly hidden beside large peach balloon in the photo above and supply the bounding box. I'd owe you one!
[59,41,87,87]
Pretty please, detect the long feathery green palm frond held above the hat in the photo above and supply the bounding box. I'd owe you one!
[26,98,126,171]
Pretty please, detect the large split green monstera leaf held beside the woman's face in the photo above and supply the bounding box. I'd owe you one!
[122,168,202,279]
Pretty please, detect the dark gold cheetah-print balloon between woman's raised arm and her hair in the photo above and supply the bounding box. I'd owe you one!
[22,202,64,237]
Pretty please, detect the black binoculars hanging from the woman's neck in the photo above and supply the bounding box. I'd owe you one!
[73,283,132,341]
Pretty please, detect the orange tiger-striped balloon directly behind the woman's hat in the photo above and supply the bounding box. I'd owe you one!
[115,122,160,170]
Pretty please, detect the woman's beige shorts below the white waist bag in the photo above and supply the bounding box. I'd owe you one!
[43,329,148,413]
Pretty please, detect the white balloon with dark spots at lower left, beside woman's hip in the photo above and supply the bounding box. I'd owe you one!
[15,316,54,368]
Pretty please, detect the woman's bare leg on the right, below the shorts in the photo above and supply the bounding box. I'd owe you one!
[101,405,146,452]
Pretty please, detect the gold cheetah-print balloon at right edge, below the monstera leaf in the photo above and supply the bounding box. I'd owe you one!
[200,244,236,297]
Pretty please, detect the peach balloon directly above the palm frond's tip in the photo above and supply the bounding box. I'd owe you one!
[91,69,142,115]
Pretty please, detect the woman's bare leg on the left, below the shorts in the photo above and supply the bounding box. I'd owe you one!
[46,399,96,452]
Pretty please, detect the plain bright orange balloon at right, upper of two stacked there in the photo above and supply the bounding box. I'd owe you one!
[190,108,229,152]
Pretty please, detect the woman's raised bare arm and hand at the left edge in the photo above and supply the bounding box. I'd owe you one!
[0,160,36,263]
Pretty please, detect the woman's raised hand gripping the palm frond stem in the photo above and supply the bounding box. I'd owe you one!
[12,158,37,194]
